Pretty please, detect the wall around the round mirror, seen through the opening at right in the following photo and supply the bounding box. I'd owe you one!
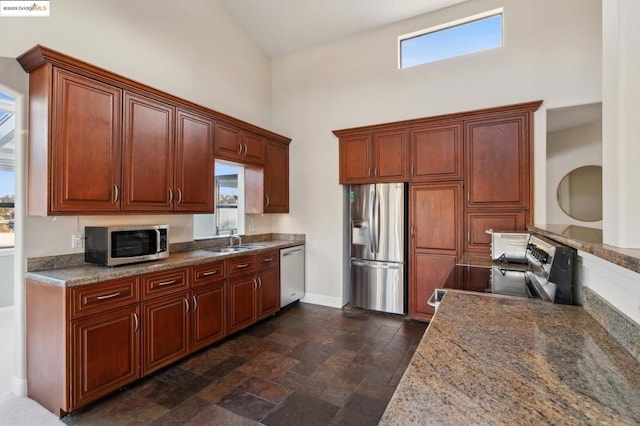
[545,121,602,228]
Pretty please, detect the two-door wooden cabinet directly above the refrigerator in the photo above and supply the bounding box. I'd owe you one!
[340,131,409,184]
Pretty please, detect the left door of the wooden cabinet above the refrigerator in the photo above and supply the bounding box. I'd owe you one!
[340,135,374,185]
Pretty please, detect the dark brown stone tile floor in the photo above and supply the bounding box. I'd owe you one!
[62,303,427,426]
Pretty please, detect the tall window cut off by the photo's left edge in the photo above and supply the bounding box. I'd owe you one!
[0,93,16,249]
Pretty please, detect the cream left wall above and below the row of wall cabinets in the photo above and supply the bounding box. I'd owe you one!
[0,0,271,257]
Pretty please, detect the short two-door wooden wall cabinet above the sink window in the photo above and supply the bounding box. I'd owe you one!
[214,122,265,165]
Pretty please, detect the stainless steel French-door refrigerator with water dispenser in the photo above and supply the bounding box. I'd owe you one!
[349,183,407,314]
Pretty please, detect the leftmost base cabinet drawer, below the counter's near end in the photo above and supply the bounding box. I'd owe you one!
[70,276,140,319]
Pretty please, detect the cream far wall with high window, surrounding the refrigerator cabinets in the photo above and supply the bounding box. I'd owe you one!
[272,0,602,304]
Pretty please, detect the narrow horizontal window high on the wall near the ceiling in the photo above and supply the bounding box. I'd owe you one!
[398,9,503,68]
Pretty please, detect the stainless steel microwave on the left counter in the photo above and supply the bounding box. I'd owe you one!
[84,225,169,266]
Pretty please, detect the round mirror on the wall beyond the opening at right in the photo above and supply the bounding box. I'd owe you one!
[557,166,602,222]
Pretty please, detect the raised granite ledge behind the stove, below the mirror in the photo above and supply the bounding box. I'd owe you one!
[529,225,640,273]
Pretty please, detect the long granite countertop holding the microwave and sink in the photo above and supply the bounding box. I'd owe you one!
[27,240,304,287]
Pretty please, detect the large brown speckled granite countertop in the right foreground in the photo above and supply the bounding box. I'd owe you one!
[380,291,640,425]
